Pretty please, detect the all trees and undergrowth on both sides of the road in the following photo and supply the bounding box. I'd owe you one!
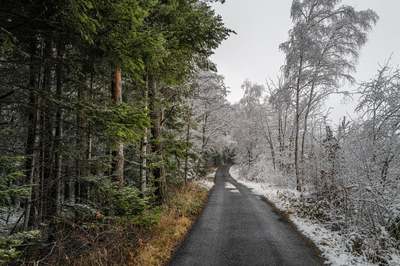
[0,0,400,265]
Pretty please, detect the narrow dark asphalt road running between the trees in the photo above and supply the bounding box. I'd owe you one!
[170,166,323,266]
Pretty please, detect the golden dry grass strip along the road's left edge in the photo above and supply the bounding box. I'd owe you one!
[129,184,207,266]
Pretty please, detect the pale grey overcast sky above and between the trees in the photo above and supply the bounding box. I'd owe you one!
[212,0,400,122]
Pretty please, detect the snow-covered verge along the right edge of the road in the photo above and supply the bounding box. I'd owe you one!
[229,165,400,266]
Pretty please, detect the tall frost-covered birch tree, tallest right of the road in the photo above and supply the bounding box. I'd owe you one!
[280,0,378,190]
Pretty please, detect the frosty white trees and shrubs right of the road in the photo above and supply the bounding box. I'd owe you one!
[231,0,400,265]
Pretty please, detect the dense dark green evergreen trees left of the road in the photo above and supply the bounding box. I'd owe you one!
[0,0,232,265]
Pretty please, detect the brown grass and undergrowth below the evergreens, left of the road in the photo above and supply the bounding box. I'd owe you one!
[18,183,208,266]
